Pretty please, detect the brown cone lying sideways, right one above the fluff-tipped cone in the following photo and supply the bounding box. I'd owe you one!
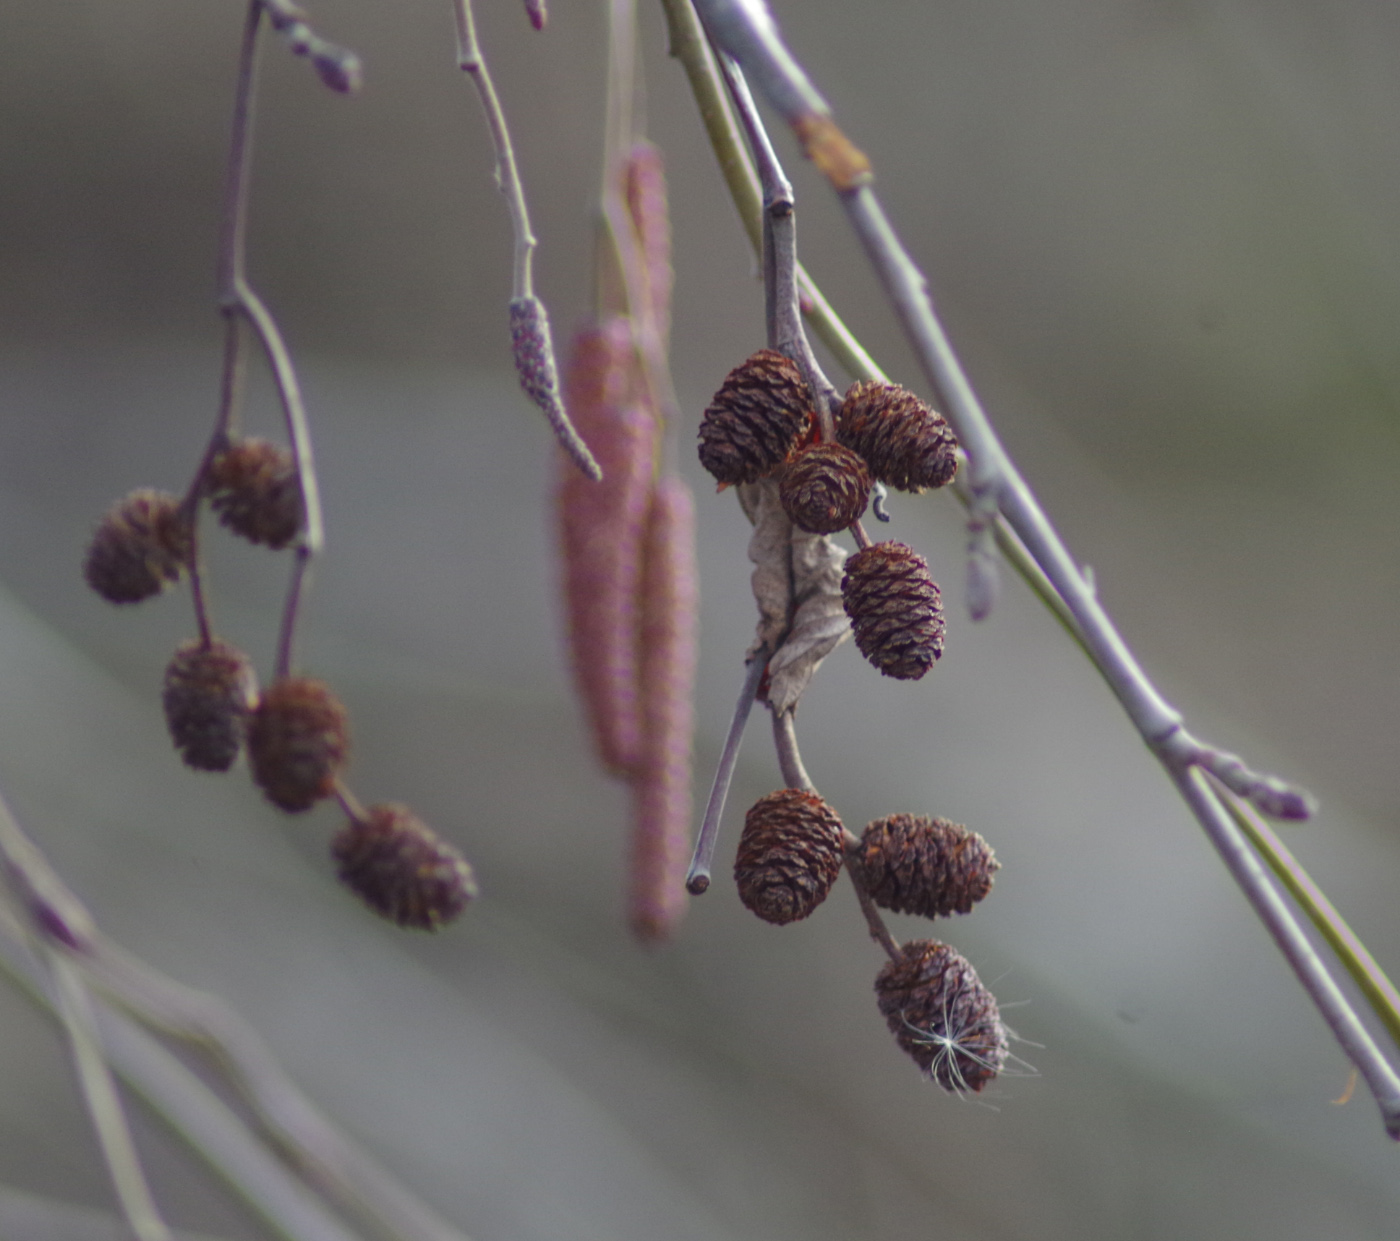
[857,814,1001,917]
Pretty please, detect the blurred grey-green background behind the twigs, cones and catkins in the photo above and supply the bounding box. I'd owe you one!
[0,0,1400,1241]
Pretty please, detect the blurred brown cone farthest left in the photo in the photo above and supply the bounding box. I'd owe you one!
[83,487,195,604]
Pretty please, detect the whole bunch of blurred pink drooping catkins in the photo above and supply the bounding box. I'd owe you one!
[556,143,699,941]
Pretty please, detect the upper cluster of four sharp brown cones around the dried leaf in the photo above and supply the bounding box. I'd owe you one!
[700,349,958,681]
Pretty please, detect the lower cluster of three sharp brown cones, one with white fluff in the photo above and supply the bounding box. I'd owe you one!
[734,789,1008,1094]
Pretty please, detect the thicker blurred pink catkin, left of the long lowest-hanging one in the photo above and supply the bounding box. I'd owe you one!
[556,317,655,775]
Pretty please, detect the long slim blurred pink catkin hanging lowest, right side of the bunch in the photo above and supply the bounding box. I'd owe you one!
[629,476,700,940]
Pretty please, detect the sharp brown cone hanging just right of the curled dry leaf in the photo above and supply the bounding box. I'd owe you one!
[841,542,944,681]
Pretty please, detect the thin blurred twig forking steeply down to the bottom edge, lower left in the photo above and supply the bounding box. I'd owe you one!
[43,948,172,1241]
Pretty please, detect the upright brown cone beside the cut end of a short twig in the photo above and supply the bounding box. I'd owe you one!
[734,789,844,926]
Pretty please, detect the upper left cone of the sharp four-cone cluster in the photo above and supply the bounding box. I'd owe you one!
[700,349,812,485]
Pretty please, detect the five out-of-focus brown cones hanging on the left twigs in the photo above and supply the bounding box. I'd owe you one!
[84,438,476,930]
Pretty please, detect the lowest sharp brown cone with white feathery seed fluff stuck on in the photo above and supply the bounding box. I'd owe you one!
[875,940,1008,1094]
